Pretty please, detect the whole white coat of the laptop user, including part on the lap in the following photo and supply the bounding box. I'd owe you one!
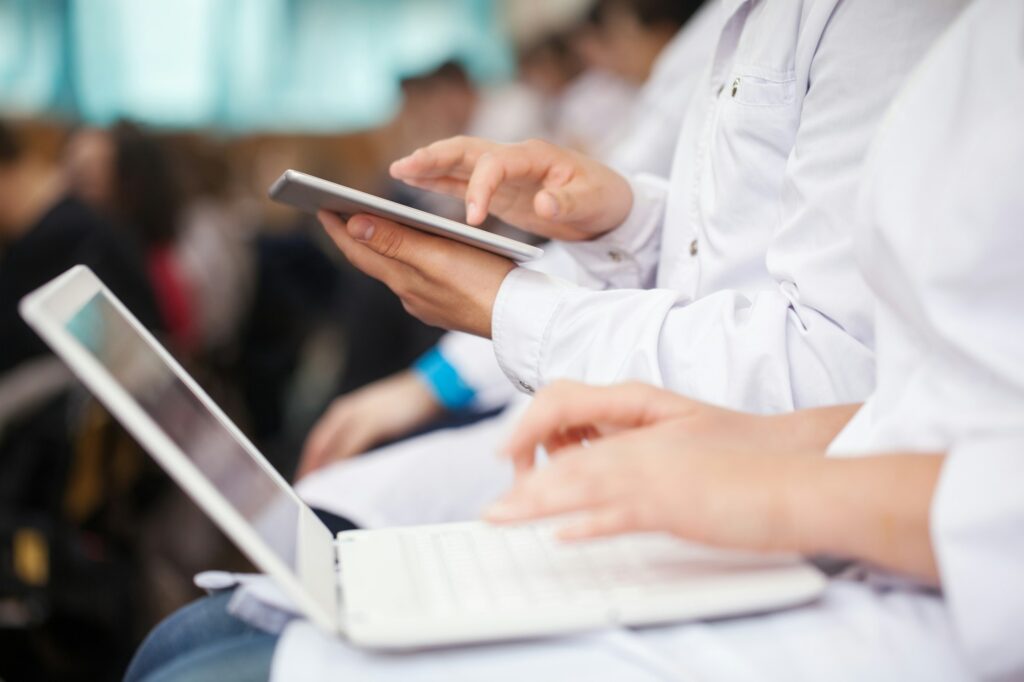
[273,0,1024,681]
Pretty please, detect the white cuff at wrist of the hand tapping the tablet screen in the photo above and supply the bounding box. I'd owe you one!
[565,174,668,289]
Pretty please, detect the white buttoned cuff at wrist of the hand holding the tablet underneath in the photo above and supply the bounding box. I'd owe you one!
[490,267,574,393]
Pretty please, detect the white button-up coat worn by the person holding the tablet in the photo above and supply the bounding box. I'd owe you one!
[493,0,965,412]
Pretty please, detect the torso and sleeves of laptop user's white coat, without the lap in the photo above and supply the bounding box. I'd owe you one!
[834,0,1024,679]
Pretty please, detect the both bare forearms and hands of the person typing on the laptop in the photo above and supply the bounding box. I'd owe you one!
[487,382,944,583]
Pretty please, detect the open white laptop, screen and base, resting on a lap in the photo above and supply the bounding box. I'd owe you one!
[22,266,825,649]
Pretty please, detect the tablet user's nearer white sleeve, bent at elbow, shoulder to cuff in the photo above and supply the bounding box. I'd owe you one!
[493,3,939,412]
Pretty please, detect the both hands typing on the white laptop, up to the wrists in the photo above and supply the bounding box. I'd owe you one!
[485,382,843,551]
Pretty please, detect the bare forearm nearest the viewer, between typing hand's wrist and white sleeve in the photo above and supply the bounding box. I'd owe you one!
[772,454,945,584]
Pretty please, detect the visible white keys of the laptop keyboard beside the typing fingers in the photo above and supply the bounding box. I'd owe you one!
[402,525,678,612]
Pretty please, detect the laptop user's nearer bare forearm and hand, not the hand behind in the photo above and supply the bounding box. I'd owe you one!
[486,444,945,584]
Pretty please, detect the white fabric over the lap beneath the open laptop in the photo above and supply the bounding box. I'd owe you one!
[270,581,975,682]
